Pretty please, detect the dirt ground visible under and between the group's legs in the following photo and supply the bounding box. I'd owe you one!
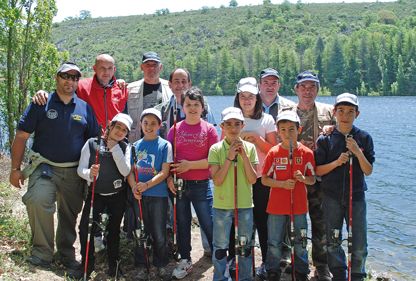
[0,155,322,281]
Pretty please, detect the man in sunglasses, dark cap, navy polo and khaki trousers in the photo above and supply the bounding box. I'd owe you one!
[10,62,99,273]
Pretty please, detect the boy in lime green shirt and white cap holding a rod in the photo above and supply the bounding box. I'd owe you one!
[208,107,259,280]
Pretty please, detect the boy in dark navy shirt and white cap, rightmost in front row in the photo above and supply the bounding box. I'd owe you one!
[315,93,375,281]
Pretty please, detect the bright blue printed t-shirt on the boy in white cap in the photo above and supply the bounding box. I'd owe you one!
[134,137,173,197]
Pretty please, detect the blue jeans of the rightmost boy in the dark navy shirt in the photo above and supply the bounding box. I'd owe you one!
[323,196,368,281]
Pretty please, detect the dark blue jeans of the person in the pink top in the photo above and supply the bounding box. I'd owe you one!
[176,180,212,260]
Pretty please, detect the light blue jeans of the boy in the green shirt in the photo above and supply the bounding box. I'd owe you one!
[212,208,253,281]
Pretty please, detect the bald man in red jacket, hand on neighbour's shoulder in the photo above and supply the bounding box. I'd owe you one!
[32,54,128,129]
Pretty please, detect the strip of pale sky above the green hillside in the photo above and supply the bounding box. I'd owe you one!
[54,0,393,22]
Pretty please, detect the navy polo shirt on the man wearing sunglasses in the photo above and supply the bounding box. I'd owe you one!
[17,92,99,163]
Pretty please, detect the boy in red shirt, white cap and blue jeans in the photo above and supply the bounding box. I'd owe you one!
[261,110,315,281]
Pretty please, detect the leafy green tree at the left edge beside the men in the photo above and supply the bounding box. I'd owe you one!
[0,0,63,147]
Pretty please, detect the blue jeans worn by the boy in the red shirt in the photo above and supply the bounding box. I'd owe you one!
[266,214,309,274]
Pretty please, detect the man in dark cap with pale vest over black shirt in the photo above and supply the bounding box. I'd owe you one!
[127,52,172,142]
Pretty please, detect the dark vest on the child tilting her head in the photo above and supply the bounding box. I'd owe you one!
[88,138,127,194]
